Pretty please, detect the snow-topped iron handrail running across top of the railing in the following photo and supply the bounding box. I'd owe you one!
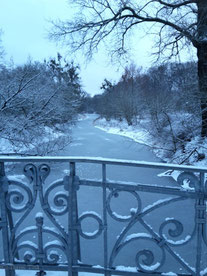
[0,156,207,173]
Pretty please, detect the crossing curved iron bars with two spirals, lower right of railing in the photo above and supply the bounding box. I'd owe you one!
[109,197,196,273]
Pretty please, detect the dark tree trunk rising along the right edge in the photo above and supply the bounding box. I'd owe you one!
[197,0,207,137]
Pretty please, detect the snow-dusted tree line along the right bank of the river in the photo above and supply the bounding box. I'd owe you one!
[84,62,202,160]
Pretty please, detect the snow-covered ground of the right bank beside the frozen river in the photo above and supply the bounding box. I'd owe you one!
[94,116,207,167]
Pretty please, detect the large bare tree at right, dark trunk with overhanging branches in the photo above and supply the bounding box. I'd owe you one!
[51,0,207,137]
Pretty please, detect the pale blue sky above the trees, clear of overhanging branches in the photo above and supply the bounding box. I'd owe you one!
[0,0,194,95]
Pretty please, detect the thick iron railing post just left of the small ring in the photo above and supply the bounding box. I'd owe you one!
[68,162,81,276]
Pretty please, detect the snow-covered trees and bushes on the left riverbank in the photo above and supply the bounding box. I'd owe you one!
[0,62,82,154]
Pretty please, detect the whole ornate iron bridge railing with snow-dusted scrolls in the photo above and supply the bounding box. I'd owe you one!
[0,157,207,276]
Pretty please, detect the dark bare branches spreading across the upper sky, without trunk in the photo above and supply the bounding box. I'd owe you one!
[50,0,197,57]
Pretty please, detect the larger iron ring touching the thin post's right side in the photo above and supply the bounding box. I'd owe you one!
[106,189,141,222]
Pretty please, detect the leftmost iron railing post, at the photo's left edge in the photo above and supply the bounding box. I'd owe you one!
[0,162,15,276]
